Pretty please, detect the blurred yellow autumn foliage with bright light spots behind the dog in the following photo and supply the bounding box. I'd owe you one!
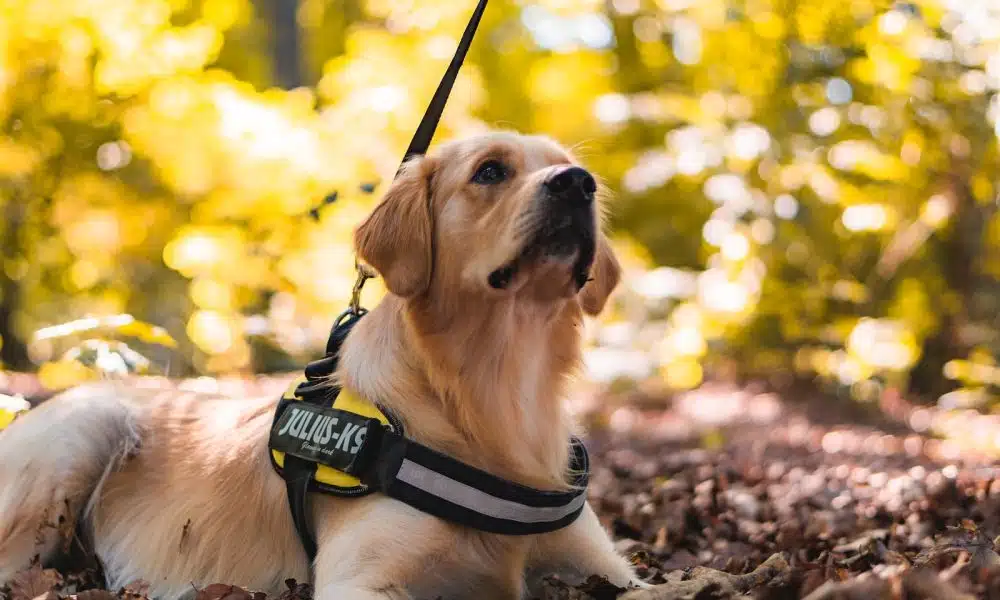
[0,0,1000,438]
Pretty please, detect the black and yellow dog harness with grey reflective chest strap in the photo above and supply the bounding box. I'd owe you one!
[268,311,589,559]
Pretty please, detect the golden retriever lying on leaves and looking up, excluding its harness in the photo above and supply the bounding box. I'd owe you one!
[0,133,642,600]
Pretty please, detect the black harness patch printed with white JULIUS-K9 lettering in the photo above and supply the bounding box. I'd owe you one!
[270,403,377,472]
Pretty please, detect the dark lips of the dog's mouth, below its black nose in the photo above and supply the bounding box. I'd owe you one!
[488,215,596,291]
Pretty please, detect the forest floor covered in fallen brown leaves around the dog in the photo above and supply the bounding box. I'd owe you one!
[0,372,1000,600]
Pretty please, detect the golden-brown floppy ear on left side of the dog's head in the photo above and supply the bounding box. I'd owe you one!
[354,156,433,298]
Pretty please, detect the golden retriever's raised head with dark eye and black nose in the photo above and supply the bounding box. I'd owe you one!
[355,133,619,314]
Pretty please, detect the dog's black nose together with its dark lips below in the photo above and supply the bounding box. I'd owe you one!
[489,166,597,289]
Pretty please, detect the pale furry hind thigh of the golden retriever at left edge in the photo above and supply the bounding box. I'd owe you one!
[0,384,140,585]
